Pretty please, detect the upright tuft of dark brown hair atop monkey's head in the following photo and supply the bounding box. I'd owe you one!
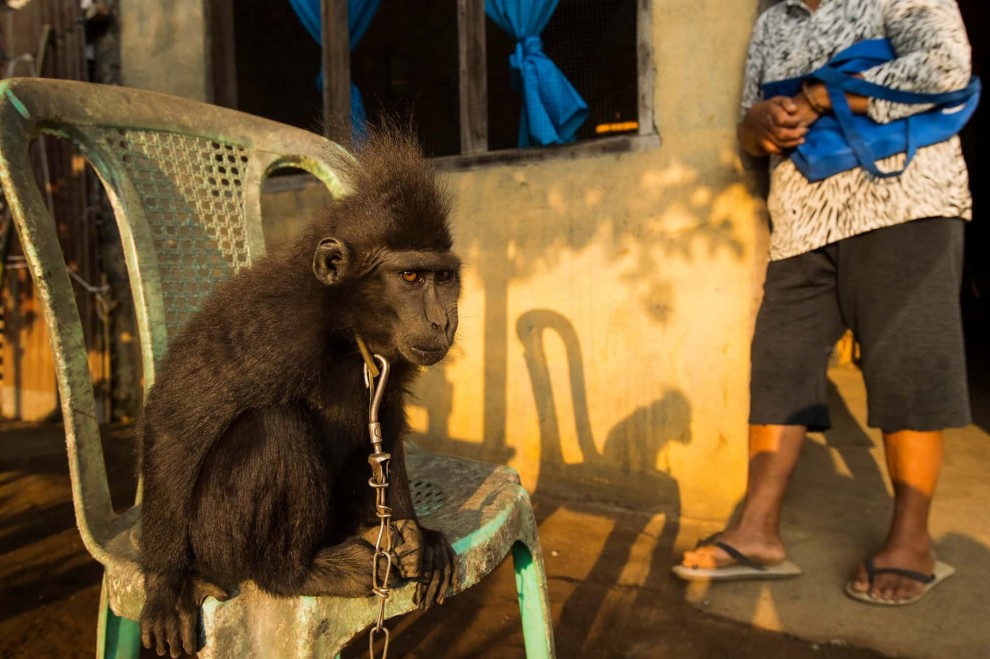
[324,123,453,251]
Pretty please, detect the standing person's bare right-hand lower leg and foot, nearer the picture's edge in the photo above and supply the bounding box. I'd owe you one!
[853,430,945,601]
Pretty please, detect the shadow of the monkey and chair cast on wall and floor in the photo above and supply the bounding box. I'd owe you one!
[416,309,691,656]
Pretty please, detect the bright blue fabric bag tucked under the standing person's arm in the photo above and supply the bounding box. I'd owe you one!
[763,39,980,182]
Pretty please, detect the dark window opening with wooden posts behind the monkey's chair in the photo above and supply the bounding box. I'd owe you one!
[213,0,658,167]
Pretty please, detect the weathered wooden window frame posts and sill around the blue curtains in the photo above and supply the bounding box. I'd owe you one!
[320,0,660,170]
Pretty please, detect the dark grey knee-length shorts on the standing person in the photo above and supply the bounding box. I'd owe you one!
[749,218,970,432]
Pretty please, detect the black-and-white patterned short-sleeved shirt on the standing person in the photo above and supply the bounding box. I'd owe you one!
[740,0,972,260]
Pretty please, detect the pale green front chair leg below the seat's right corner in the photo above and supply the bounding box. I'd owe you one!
[512,542,556,659]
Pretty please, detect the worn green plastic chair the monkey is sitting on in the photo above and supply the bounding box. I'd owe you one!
[0,78,554,659]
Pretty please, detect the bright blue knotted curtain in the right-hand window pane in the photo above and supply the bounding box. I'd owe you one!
[485,0,588,147]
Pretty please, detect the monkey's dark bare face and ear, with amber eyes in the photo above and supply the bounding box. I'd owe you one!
[313,238,461,366]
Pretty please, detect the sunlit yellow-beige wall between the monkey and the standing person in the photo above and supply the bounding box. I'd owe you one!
[266,0,765,518]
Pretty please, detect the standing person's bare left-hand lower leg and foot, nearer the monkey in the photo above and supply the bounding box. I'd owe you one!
[682,426,807,569]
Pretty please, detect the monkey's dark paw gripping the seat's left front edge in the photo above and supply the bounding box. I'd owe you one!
[141,575,229,658]
